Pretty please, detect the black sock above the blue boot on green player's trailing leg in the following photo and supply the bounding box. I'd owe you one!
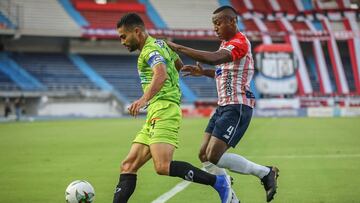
[169,161,216,186]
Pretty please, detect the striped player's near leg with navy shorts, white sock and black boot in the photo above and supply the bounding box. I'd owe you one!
[206,105,278,201]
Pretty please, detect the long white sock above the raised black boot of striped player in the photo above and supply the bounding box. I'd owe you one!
[217,153,270,179]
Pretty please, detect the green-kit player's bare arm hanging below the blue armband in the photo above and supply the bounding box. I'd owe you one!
[128,63,168,116]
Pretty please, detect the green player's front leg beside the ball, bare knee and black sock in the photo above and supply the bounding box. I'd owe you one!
[113,143,151,203]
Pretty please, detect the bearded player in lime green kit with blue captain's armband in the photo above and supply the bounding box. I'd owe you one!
[113,13,232,203]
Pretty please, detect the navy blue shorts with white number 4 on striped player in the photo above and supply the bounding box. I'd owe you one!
[205,104,253,147]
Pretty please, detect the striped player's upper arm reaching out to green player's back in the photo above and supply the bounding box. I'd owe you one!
[166,41,233,65]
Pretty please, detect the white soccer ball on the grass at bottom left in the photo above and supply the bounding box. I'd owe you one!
[65,180,95,203]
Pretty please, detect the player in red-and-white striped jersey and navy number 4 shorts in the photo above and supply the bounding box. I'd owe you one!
[168,6,279,202]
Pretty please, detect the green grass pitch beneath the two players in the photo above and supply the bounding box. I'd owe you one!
[0,118,360,203]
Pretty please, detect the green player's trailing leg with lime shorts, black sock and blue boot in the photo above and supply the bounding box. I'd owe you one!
[149,101,231,203]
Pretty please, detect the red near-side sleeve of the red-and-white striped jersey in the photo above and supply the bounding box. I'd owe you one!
[223,38,249,61]
